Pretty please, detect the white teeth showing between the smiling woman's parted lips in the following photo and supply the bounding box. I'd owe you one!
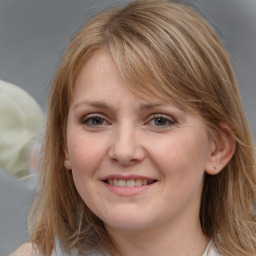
[104,179,156,187]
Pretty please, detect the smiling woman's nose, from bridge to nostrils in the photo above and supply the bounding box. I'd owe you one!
[109,124,145,166]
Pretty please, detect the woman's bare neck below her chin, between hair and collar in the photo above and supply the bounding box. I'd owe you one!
[107,220,209,256]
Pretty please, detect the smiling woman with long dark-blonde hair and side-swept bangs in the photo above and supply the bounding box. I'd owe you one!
[14,0,256,256]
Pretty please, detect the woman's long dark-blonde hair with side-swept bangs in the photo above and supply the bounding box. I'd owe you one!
[28,0,256,256]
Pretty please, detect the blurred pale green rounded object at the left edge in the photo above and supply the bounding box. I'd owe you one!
[0,80,44,178]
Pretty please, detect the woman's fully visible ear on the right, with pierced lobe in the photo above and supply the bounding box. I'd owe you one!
[205,124,235,175]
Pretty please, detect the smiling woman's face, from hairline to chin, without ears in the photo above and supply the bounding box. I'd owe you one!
[66,51,215,234]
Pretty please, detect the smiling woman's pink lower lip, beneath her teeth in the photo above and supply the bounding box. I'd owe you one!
[103,182,155,196]
